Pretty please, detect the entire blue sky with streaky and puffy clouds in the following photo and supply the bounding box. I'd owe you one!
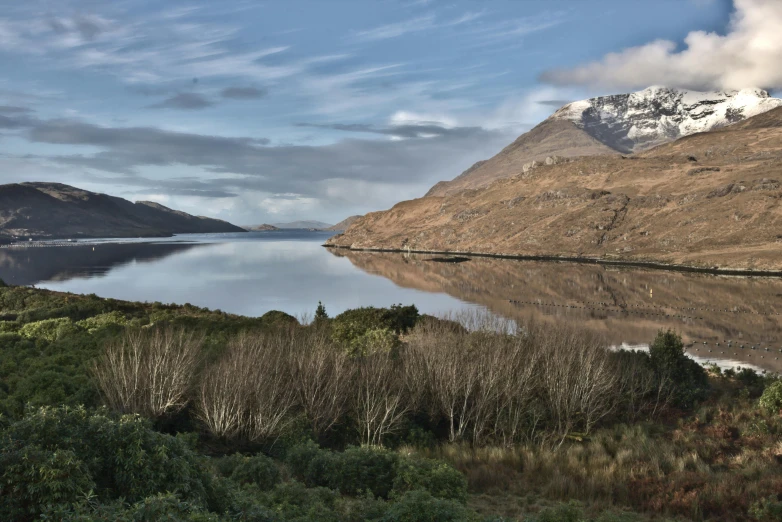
[0,0,782,225]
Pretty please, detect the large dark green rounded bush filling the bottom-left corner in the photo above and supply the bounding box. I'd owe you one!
[0,407,217,520]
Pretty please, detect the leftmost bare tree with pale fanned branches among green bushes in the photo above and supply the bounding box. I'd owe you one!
[93,328,203,418]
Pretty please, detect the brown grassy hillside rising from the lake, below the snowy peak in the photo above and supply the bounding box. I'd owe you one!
[327,103,782,270]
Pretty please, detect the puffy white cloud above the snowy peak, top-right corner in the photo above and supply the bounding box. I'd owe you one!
[541,0,782,90]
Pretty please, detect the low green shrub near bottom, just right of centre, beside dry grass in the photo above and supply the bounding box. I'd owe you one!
[393,457,467,503]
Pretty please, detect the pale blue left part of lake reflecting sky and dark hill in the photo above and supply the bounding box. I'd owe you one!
[15,231,475,316]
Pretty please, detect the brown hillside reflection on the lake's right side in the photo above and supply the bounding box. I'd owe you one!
[332,250,782,371]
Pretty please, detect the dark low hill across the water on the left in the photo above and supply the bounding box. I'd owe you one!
[0,183,244,239]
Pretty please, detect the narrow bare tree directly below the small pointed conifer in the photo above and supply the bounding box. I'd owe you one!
[290,331,354,437]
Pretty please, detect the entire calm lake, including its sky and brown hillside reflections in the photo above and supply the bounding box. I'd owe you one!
[0,230,782,371]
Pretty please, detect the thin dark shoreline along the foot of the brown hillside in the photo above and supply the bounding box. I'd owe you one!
[321,243,782,277]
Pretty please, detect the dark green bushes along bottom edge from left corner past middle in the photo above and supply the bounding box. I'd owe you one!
[0,408,484,521]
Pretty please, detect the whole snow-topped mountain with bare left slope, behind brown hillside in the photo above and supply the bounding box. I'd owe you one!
[426,87,782,196]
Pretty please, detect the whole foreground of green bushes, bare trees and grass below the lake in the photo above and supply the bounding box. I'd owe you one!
[0,284,782,522]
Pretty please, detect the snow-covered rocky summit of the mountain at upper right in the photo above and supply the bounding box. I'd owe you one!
[549,87,782,153]
